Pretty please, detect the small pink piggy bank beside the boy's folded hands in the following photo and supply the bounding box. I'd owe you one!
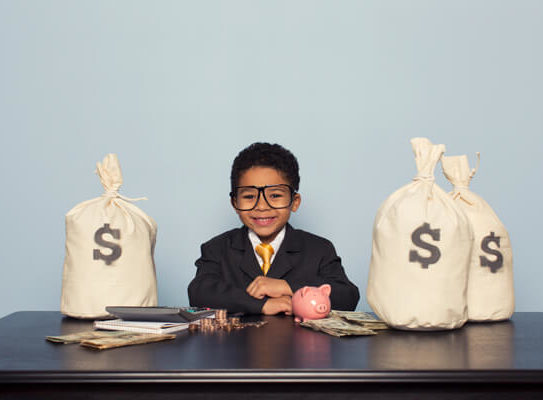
[292,284,332,322]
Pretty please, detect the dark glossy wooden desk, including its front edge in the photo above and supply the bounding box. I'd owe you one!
[0,312,543,400]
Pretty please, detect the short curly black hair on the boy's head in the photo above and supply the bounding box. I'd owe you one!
[230,142,300,192]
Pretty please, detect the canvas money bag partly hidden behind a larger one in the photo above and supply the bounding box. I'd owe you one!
[441,154,515,321]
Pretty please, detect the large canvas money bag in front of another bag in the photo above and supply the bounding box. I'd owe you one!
[366,138,473,330]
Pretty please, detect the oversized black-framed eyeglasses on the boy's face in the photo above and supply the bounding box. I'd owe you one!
[230,184,296,211]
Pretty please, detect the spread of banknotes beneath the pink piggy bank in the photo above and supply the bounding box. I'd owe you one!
[300,310,388,337]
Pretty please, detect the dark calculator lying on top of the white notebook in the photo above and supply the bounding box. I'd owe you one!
[106,306,215,322]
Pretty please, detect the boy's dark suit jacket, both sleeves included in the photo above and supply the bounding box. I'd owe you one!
[188,224,360,314]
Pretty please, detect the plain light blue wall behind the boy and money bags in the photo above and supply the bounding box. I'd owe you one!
[0,0,543,316]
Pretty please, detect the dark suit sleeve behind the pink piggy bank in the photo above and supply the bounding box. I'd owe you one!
[287,240,360,311]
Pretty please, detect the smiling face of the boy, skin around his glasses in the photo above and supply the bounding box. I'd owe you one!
[236,167,302,243]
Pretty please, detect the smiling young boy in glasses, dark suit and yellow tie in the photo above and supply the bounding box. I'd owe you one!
[188,143,360,315]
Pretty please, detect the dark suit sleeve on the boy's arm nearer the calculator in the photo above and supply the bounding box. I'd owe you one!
[188,244,267,314]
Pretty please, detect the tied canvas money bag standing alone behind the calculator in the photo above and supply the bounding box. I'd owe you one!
[60,154,157,318]
